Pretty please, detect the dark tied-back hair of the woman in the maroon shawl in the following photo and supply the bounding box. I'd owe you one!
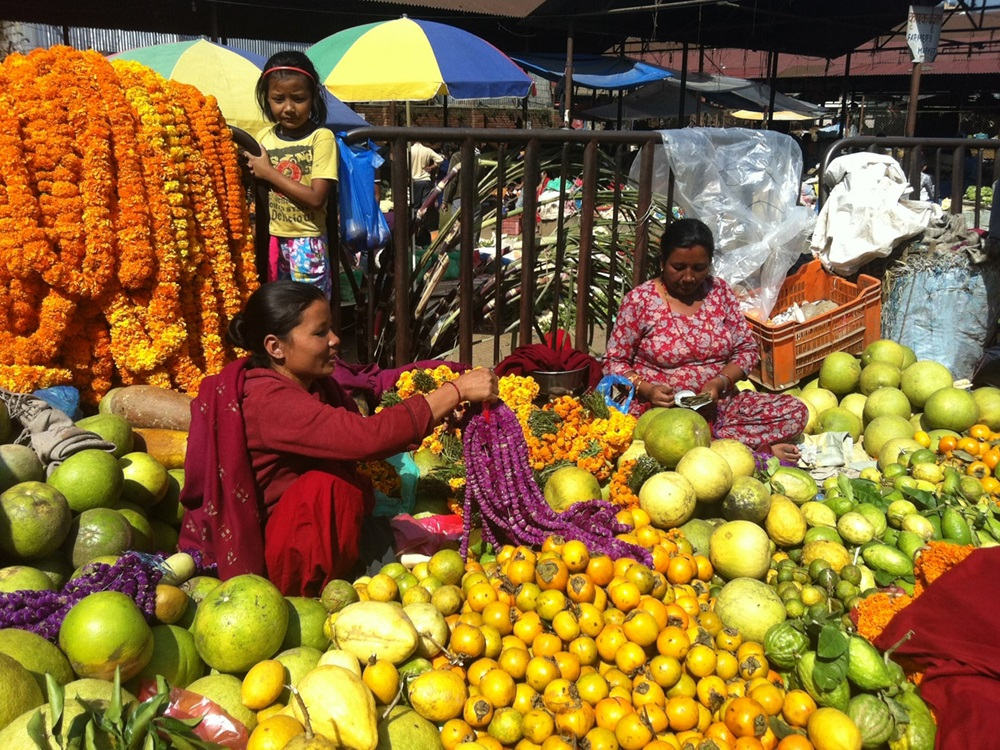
[226,281,326,367]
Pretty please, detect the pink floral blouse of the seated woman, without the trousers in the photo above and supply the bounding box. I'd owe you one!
[604,276,760,393]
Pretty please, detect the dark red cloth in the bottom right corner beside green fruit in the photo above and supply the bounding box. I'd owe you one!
[875,547,1000,748]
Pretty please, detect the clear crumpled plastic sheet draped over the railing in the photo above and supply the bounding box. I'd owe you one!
[632,128,816,320]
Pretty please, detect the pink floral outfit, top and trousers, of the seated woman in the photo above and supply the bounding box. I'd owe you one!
[604,277,809,450]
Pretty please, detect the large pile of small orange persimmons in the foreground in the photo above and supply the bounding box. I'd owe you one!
[400,508,860,750]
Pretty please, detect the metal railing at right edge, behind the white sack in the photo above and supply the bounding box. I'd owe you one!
[817,136,1000,227]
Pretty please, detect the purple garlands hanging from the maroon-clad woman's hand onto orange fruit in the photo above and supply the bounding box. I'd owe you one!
[461,402,652,565]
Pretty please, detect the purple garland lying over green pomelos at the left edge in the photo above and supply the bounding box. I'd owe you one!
[0,552,163,643]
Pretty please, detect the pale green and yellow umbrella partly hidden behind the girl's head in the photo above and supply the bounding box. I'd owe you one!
[111,39,368,133]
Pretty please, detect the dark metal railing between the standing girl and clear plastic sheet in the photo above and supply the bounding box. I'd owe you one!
[331,127,662,364]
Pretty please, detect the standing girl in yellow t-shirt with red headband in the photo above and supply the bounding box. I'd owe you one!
[247,51,337,298]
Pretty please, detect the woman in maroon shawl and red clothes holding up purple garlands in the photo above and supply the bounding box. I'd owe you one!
[179,281,497,596]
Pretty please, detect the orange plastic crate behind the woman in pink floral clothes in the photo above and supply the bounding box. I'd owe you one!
[746,260,882,390]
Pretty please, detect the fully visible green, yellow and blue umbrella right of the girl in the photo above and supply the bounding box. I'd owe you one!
[306,16,532,102]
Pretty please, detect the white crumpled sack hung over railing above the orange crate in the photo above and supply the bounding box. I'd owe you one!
[812,151,941,276]
